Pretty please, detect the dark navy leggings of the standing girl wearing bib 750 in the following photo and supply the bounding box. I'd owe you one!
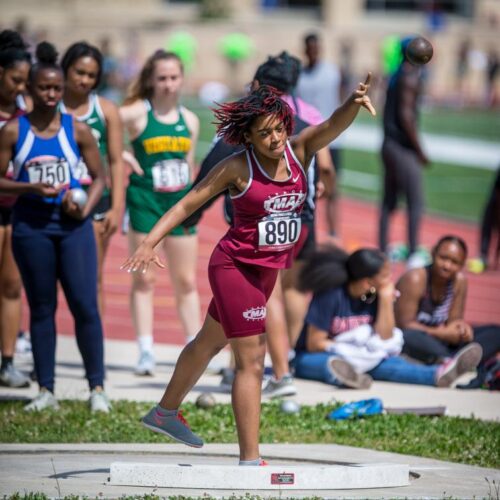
[12,219,104,391]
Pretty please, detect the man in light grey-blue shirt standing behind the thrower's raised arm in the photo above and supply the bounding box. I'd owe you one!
[296,33,341,237]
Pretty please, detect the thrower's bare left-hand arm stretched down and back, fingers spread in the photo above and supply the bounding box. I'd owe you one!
[121,157,241,272]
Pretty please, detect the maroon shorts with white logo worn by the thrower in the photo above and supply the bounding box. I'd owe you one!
[208,246,279,339]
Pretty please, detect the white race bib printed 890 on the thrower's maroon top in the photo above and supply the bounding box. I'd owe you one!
[258,213,302,251]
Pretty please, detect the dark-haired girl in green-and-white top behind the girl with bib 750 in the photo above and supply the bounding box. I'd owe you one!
[60,42,124,314]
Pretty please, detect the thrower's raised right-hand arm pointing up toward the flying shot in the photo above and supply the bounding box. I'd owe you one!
[294,73,376,165]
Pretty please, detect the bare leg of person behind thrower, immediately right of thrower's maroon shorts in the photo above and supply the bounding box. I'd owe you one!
[266,277,289,380]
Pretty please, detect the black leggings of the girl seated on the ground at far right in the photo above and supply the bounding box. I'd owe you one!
[403,325,500,365]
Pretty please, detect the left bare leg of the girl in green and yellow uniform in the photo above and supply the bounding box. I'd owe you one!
[128,229,156,344]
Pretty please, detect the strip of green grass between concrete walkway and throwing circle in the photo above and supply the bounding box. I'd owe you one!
[0,401,500,468]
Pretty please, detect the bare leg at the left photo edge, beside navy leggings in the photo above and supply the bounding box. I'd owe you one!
[0,225,22,357]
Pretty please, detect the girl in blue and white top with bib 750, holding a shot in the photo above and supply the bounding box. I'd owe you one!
[0,42,109,411]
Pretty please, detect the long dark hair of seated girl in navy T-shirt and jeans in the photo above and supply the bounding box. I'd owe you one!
[298,245,386,293]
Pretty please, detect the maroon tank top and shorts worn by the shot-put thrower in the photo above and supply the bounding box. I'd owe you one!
[208,143,307,338]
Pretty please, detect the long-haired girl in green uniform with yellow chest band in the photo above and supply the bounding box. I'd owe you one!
[120,50,201,375]
